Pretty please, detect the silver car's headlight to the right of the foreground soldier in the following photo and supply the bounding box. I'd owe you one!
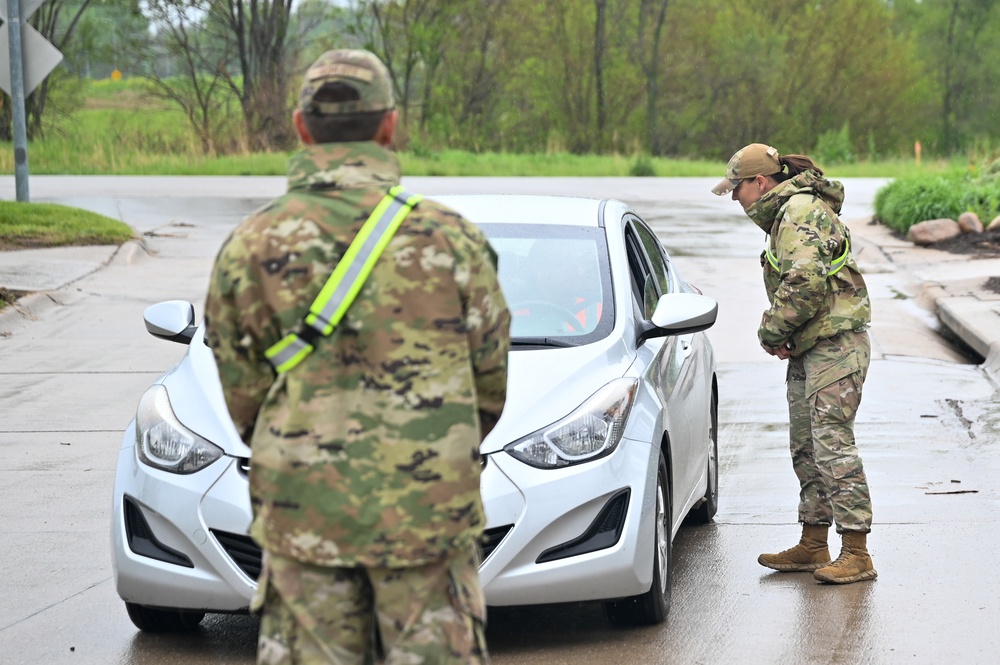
[504,379,639,469]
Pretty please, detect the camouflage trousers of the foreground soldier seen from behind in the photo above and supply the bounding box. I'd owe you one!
[251,551,488,665]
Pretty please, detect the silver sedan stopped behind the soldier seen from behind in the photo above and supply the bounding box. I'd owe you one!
[112,196,718,631]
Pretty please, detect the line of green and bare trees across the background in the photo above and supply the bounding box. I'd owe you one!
[0,0,1000,161]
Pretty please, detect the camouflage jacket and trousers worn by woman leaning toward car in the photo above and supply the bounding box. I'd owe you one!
[747,171,872,532]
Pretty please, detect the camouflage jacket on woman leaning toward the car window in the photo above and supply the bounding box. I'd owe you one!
[747,171,871,356]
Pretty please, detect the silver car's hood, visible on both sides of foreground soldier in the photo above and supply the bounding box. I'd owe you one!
[160,328,634,457]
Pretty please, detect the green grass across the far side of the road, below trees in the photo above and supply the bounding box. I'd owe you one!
[0,79,963,178]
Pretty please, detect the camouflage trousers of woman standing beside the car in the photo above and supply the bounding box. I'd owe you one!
[787,331,872,533]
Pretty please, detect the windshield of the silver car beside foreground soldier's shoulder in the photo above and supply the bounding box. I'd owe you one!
[482,224,614,347]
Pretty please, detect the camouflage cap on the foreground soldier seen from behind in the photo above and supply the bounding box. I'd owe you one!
[299,49,395,115]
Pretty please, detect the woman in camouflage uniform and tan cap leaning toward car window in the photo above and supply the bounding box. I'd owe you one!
[712,143,876,584]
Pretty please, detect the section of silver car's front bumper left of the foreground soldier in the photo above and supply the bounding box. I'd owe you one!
[111,423,260,612]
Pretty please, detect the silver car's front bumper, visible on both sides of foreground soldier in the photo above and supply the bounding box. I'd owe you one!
[111,425,659,612]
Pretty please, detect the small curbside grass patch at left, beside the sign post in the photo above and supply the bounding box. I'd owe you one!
[0,201,135,250]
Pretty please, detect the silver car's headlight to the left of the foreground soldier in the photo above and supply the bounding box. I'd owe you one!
[135,384,223,474]
